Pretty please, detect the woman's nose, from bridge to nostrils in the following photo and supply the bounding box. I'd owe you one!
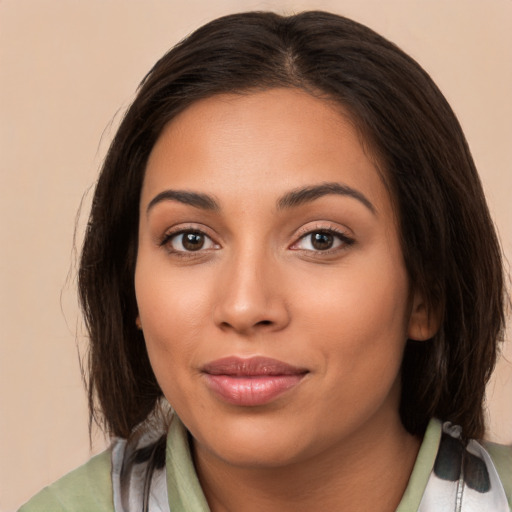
[214,249,290,336]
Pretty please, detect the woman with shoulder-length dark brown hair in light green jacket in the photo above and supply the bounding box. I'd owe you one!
[18,12,512,512]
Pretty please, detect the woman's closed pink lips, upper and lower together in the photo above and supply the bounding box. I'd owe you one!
[201,357,308,407]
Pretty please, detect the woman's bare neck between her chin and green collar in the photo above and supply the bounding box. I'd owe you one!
[194,410,420,512]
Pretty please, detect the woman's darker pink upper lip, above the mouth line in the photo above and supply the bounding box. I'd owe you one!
[202,356,308,377]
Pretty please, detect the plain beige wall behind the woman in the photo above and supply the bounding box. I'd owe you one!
[0,0,512,512]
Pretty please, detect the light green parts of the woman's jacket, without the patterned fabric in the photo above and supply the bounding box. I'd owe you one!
[19,420,512,512]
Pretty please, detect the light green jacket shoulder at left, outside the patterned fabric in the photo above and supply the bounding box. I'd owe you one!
[18,450,114,512]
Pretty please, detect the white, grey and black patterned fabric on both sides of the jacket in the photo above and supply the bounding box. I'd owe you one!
[112,414,510,512]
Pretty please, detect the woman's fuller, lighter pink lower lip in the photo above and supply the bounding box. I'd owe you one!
[205,373,304,407]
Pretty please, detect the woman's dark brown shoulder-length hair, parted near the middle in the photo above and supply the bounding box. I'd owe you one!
[79,12,504,437]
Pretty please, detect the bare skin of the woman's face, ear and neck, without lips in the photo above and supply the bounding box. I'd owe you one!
[135,89,432,512]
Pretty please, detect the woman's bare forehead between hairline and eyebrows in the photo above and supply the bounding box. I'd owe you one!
[142,89,389,214]
